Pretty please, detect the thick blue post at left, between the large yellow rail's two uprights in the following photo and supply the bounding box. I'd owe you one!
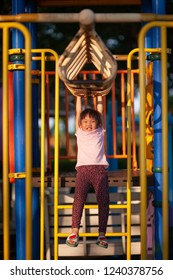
[12,0,26,260]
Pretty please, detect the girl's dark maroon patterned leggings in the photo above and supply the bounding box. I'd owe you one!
[72,165,109,233]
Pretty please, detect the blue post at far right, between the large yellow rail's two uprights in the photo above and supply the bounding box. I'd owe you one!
[152,0,165,259]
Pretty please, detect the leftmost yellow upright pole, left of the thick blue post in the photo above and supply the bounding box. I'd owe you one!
[1,24,10,260]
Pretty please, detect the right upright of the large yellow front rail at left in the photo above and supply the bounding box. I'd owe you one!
[24,24,32,260]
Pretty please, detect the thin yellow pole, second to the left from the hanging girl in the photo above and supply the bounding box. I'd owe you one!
[40,52,45,260]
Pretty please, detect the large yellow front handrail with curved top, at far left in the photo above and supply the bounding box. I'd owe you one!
[0,22,32,260]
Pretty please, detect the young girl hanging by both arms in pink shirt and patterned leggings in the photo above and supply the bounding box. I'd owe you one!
[66,97,109,248]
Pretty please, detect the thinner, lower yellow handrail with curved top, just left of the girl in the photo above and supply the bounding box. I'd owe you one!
[27,49,59,260]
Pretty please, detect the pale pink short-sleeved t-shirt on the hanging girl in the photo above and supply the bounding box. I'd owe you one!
[75,127,109,168]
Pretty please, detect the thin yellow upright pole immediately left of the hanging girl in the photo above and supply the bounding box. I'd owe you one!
[54,53,59,260]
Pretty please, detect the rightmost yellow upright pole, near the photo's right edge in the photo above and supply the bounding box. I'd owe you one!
[161,25,169,260]
